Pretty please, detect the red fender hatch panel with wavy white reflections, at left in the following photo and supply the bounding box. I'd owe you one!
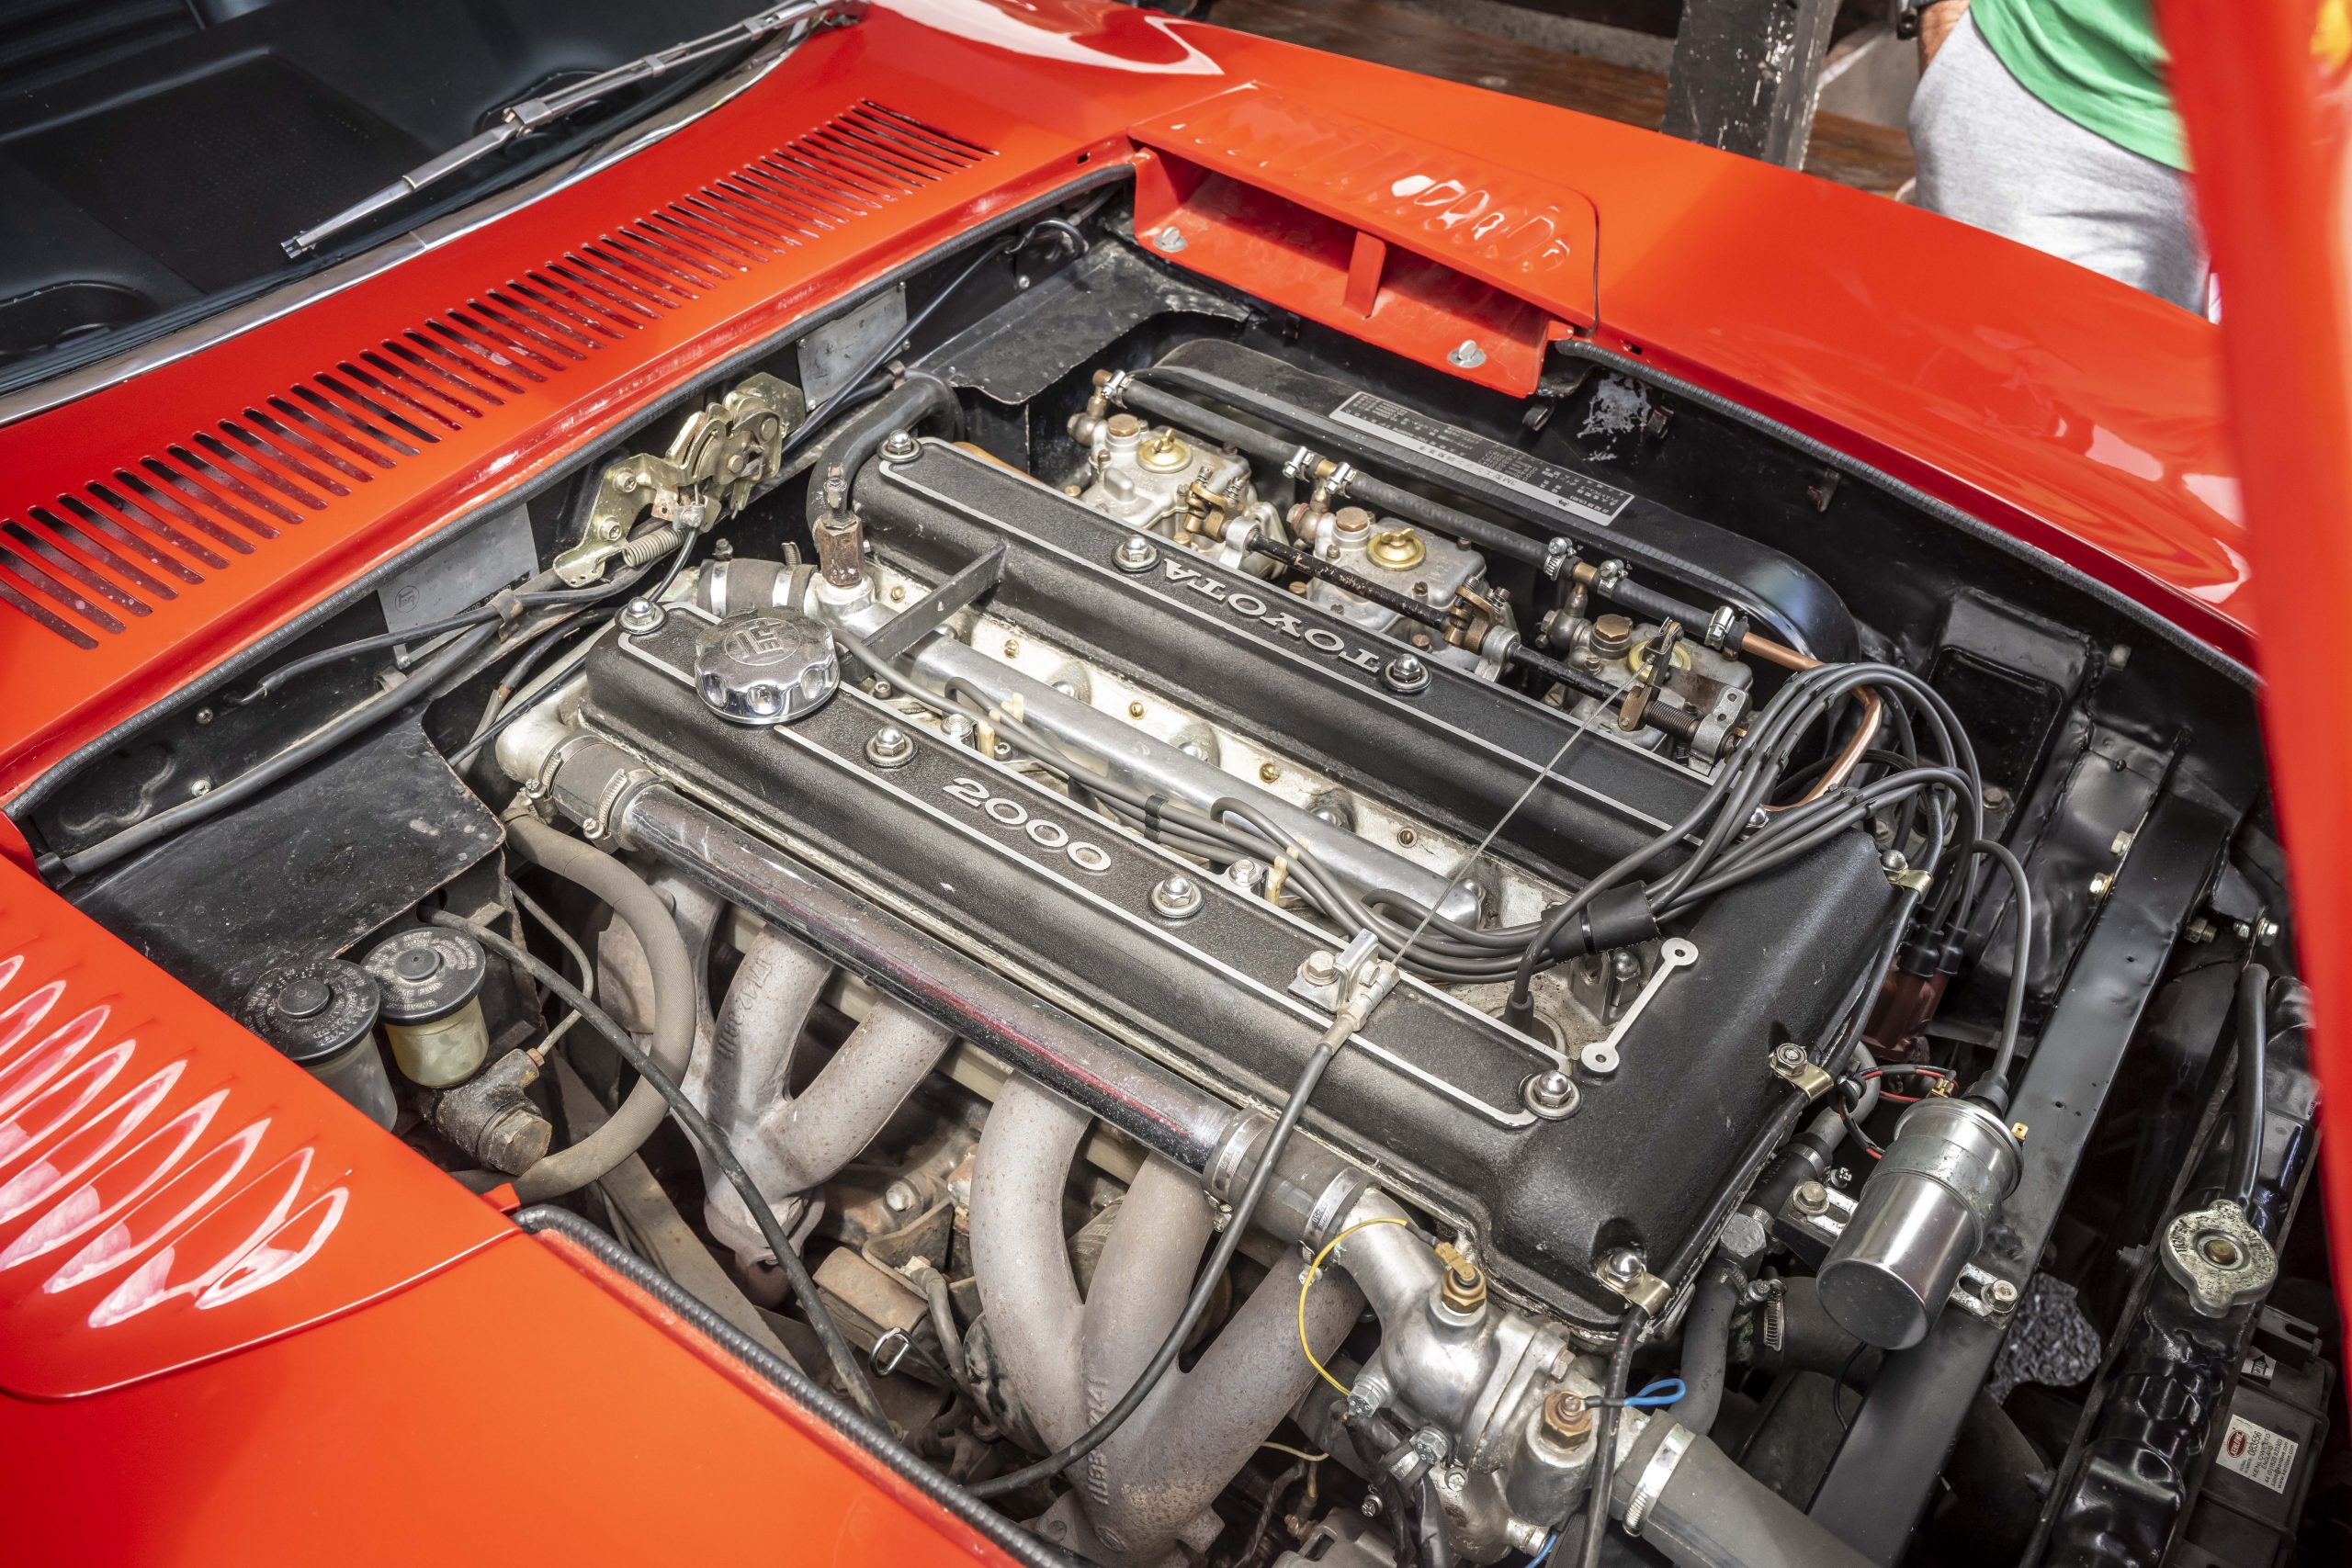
[0,865,511,1399]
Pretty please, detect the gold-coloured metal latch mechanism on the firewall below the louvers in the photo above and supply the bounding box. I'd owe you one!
[555,371,809,588]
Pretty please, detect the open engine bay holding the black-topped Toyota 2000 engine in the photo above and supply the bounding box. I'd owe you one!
[17,186,2334,1568]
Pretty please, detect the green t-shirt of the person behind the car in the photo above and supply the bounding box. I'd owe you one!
[1969,0,2188,169]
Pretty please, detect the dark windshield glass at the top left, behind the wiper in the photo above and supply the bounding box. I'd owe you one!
[0,0,804,390]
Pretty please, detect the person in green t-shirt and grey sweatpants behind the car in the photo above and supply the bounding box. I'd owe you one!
[1910,0,2211,315]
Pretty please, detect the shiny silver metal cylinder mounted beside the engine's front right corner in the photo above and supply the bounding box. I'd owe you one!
[1820,1100,2018,1349]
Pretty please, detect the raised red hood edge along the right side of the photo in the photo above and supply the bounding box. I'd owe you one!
[2159,0,2352,1293]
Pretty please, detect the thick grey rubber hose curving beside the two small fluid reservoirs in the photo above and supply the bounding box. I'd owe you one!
[505,816,696,1203]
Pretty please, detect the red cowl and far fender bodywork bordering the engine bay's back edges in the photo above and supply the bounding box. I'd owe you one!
[0,0,2246,827]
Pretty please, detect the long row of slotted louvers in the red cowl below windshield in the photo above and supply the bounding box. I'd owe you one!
[0,101,992,649]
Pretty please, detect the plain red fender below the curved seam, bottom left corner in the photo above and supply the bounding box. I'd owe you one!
[0,1211,1007,1568]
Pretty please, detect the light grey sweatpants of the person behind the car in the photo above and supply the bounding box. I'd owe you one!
[1910,17,2206,312]
